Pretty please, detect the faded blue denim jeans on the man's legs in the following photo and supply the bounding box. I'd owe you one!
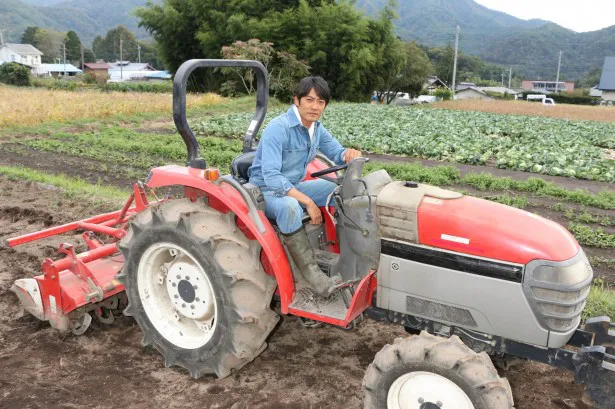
[263,179,336,234]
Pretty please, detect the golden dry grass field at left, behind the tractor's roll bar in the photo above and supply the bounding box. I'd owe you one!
[0,84,223,127]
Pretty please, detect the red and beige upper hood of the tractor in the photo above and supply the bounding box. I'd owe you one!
[377,182,580,264]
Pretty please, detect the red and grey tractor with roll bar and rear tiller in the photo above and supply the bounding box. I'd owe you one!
[6,60,615,409]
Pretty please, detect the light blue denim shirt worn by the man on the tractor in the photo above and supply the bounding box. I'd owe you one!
[248,106,345,196]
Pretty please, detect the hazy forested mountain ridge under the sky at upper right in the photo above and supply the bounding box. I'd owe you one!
[356,0,615,80]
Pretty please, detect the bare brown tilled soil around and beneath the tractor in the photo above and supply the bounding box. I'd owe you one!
[0,177,587,409]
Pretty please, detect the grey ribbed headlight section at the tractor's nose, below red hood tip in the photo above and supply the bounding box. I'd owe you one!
[523,250,594,332]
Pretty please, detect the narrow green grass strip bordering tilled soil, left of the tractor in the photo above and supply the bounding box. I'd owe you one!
[0,166,128,206]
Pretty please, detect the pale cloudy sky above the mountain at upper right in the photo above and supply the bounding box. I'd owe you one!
[475,0,615,32]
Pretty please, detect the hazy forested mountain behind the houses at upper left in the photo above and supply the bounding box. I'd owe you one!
[0,0,148,44]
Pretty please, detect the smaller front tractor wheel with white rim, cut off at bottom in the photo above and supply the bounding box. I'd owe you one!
[363,332,513,409]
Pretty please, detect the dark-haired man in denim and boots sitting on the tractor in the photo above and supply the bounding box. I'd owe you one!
[248,77,361,297]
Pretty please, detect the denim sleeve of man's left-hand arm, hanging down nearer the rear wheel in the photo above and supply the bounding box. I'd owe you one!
[259,123,293,195]
